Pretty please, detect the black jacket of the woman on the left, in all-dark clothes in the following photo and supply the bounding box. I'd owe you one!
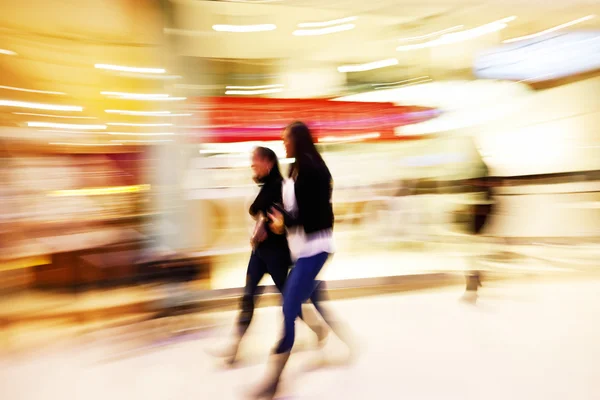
[249,169,289,251]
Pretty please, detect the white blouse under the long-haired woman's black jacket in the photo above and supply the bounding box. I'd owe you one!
[282,179,335,261]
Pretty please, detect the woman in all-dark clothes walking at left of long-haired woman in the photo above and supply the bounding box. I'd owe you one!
[211,147,327,365]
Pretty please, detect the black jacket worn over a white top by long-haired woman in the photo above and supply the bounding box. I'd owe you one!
[284,160,334,234]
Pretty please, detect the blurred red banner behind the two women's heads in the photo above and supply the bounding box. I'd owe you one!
[189,97,439,143]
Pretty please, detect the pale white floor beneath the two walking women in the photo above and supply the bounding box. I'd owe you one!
[0,281,600,400]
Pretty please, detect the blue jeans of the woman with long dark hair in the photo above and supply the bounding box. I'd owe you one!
[275,253,329,354]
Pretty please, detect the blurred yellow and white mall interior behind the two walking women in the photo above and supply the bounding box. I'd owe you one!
[0,0,600,398]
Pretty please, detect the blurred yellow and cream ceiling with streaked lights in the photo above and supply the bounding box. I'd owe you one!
[0,0,600,146]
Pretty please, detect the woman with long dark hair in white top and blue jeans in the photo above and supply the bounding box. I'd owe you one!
[246,122,339,399]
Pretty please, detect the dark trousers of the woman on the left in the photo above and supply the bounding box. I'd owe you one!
[237,247,324,337]
